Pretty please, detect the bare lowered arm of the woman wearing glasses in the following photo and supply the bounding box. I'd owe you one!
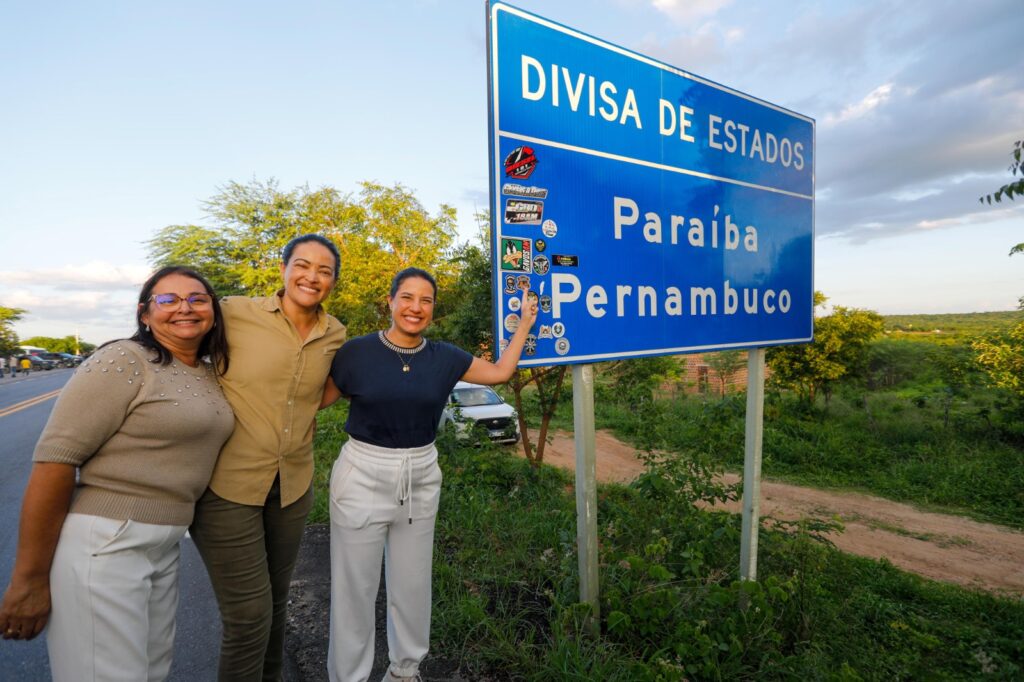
[0,462,75,639]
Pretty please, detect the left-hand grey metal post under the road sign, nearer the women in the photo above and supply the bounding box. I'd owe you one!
[572,365,600,630]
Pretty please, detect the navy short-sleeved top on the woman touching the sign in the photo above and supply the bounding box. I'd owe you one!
[331,332,473,447]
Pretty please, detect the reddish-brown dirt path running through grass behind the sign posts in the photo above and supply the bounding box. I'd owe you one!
[519,431,1024,595]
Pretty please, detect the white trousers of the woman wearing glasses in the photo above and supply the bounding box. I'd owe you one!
[46,514,187,682]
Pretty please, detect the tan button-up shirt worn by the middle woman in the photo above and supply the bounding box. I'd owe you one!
[210,294,345,506]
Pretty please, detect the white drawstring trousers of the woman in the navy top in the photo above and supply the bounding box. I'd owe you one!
[328,438,441,682]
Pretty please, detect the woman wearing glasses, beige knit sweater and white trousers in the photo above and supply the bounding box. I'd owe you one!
[0,266,234,682]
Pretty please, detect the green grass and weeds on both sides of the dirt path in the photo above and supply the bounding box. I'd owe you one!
[311,382,1024,681]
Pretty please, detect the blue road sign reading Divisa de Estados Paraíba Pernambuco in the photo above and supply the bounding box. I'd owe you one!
[487,2,814,366]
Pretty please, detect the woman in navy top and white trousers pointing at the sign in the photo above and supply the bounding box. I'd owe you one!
[324,267,537,682]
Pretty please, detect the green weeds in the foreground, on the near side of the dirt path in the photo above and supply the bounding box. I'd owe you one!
[316,425,1024,682]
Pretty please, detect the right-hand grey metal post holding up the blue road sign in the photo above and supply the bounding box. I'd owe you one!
[739,348,765,581]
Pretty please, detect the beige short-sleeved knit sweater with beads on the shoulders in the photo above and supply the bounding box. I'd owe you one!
[32,340,234,525]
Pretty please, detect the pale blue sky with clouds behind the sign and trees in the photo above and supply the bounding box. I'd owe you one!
[0,0,1024,343]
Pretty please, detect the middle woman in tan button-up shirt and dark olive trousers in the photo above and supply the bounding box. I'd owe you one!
[191,235,345,680]
